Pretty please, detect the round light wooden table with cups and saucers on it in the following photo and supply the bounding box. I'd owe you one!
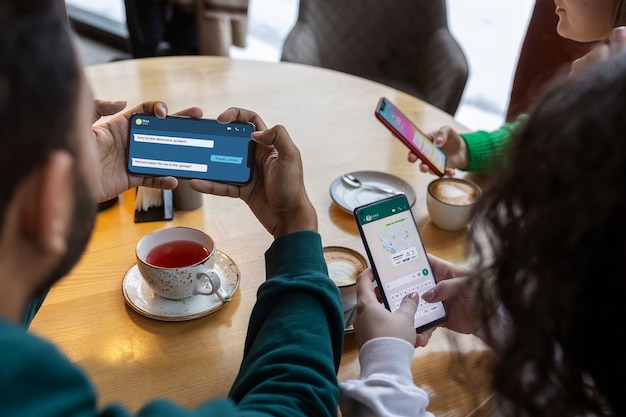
[31,57,489,416]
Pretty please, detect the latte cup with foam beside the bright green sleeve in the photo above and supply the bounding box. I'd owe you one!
[426,177,481,231]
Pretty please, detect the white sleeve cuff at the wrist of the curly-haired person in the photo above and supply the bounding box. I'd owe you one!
[339,337,433,417]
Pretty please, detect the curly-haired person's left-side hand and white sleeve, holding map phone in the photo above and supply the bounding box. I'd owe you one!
[339,268,431,417]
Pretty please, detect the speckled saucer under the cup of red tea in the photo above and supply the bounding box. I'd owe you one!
[122,250,240,321]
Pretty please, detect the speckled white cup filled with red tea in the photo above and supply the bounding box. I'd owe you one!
[135,227,231,302]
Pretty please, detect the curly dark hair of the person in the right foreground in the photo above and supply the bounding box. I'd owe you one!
[471,53,626,417]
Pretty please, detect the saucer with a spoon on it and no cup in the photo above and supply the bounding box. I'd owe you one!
[330,171,417,213]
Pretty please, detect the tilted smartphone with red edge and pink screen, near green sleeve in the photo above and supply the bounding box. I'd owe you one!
[374,97,446,177]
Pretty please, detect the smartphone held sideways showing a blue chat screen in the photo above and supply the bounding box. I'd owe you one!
[128,113,256,184]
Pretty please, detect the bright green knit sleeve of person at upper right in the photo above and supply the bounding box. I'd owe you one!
[460,114,528,175]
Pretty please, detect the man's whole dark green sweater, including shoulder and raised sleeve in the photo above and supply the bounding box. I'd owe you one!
[0,232,344,417]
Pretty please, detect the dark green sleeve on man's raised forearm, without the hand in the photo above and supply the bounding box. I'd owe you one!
[229,232,344,417]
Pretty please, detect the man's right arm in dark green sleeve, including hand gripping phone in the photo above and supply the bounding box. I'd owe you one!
[190,109,344,417]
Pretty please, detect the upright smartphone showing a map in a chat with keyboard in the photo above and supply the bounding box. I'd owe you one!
[354,194,447,333]
